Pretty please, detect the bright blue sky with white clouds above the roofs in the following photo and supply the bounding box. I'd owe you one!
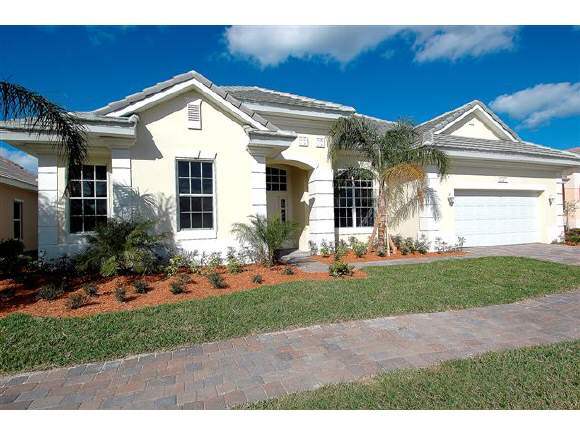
[0,26,580,171]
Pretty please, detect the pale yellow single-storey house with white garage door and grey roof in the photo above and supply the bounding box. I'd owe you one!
[0,71,580,256]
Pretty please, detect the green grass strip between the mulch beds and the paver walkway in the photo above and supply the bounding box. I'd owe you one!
[0,257,580,372]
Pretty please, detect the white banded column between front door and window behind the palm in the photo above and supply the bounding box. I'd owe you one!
[308,167,335,246]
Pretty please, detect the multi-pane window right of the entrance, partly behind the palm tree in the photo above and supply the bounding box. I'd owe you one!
[334,171,375,227]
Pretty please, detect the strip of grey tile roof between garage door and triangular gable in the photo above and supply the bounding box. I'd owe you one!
[433,134,580,165]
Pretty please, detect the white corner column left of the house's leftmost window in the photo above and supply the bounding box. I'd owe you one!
[38,155,59,259]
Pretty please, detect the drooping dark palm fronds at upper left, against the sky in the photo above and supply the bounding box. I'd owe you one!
[0,81,87,178]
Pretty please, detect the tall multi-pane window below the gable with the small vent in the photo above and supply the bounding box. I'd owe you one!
[177,160,214,230]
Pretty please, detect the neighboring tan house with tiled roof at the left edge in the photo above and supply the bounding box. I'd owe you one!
[0,157,38,251]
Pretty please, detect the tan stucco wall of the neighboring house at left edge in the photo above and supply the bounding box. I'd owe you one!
[0,183,38,250]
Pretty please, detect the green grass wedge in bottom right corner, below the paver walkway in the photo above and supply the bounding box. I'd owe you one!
[247,341,580,409]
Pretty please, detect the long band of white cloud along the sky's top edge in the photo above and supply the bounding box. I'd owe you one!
[225,26,517,67]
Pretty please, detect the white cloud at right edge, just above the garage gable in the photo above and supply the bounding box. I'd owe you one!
[490,82,580,127]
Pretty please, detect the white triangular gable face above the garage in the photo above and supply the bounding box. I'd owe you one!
[435,106,516,141]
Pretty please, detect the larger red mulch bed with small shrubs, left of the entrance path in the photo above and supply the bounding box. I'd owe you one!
[0,265,366,318]
